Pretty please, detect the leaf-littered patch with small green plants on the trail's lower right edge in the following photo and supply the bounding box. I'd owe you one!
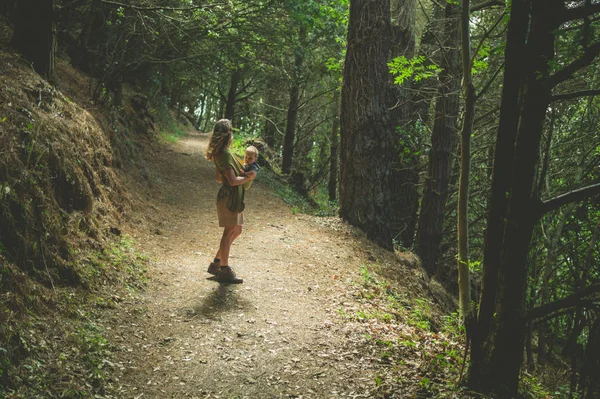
[339,264,468,398]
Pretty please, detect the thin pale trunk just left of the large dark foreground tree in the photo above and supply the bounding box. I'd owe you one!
[458,0,476,322]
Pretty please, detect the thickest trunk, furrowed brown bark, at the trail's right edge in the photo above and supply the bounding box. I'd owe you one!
[340,0,395,249]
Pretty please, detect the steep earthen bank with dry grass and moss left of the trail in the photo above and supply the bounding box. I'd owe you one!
[0,46,158,398]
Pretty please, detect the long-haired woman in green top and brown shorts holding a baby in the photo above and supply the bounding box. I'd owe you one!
[206,119,254,284]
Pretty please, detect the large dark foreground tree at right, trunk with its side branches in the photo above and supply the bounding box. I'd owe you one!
[469,0,600,397]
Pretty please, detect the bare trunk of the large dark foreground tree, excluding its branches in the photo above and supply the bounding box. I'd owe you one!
[469,0,562,397]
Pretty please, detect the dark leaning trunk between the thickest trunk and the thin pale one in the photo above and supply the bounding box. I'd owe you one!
[416,2,460,275]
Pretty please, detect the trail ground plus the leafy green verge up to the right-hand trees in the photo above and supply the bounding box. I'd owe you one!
[101,132,466,399]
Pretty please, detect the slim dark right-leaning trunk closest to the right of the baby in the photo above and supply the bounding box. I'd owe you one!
[281,26,306,175]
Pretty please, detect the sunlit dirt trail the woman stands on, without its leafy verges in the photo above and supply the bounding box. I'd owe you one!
[108,132,410,399]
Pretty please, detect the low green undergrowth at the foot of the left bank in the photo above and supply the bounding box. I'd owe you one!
[0,237,148,399]
